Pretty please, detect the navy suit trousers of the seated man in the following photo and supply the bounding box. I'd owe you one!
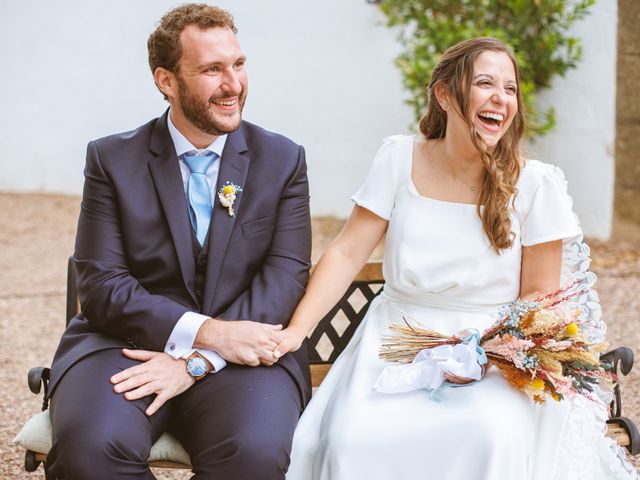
[48,349,302,480]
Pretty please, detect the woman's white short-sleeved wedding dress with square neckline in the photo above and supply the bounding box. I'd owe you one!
[287,136,635,480]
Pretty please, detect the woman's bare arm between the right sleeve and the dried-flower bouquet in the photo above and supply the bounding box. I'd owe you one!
[520,240,562,300]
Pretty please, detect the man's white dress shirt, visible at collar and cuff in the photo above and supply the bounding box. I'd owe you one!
[164,111,227,372]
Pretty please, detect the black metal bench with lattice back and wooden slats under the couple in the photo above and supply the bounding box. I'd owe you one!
[17,258,640,472]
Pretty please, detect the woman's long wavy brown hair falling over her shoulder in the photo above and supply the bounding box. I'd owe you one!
[419,37,526,253]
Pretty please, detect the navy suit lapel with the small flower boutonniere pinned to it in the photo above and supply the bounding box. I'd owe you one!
[203,127,249,312]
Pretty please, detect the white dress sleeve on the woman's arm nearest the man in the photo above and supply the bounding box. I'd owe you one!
[351,135,413,220]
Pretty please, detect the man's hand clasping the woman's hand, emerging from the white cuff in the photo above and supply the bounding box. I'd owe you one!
[193,318,282,367]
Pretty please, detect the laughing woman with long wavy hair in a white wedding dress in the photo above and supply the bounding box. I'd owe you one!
[274,38,634,480]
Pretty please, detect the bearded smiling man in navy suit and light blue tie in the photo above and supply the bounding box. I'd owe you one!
[48,4,311,480]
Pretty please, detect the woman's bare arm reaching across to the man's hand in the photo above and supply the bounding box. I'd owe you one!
[273,205,388,359]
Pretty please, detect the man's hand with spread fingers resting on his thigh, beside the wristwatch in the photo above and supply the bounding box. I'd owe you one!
[111,348,195,416]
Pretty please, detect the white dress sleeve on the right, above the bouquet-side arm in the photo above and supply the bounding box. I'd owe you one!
[521,162,582,247]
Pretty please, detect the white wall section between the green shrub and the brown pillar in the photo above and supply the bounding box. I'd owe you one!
[532,0,618,239]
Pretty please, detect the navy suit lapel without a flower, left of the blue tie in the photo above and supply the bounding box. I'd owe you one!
[149,112,196,302]
